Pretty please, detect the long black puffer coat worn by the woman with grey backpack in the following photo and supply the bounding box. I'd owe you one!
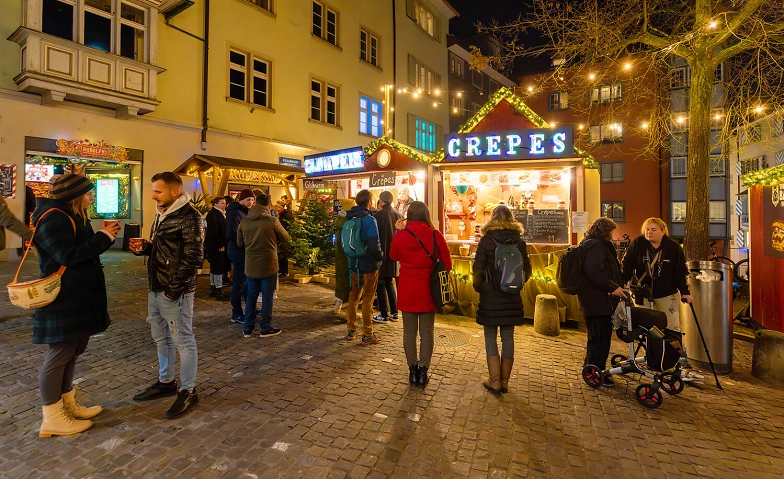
[473,221,532,326]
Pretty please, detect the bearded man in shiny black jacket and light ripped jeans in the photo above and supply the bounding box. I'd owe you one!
[133,171,205,419]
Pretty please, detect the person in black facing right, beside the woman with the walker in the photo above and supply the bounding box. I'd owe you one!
[577,218,625,387]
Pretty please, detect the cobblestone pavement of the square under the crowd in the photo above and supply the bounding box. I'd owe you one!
[0,252,784,479]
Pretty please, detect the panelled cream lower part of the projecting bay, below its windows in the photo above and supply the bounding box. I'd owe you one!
[8,27,165,118]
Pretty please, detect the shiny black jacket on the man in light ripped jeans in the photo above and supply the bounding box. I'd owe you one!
[141,193,206,300]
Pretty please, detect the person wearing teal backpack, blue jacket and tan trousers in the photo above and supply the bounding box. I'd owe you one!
[340,190,384,345]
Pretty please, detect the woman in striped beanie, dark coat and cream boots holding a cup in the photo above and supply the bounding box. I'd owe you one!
[33,174,120,437]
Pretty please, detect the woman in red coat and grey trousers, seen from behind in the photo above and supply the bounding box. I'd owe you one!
[389,201,452,386]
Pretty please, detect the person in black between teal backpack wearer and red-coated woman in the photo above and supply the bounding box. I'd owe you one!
[373,191,402,323]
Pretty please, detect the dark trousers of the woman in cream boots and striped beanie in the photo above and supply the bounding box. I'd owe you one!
[38,335,90,406]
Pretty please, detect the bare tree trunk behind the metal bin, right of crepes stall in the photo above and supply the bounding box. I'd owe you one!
[684,58,713,261]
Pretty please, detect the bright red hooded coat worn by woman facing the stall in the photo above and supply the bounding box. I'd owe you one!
[389,221,452,313]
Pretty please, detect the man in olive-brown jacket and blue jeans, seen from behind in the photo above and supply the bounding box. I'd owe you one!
[237,193,289,338]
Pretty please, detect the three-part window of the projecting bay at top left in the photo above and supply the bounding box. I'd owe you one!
[41,0,149,62]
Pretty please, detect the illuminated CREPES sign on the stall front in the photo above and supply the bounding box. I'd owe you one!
[444,127,574,161]
